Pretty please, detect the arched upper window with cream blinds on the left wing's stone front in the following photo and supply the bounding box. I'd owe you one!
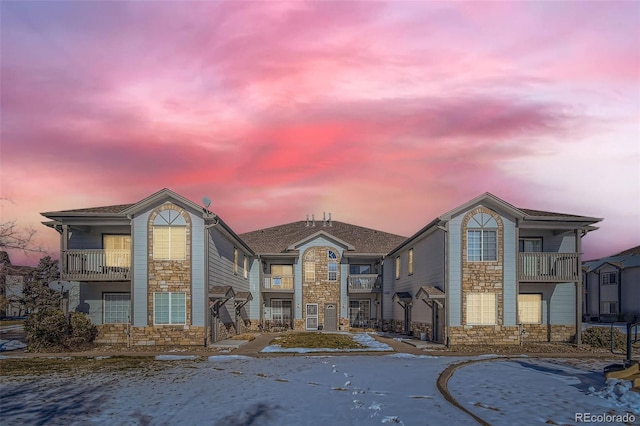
[153,210,187,260]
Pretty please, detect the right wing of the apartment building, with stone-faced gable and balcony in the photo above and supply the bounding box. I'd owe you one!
[383,193,601,345]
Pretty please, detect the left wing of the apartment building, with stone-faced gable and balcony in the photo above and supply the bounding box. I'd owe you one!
[42,189,254,345]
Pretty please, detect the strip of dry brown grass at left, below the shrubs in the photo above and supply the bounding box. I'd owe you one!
[0,356,188,376]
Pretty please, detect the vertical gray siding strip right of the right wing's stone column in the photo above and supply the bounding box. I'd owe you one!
[501,216,518,326]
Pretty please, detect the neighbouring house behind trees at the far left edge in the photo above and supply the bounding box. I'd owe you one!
[0,251,33,317]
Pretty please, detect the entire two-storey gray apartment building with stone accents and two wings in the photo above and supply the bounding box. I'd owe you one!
[43,189,601,345]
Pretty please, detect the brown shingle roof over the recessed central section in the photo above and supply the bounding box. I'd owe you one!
[239,220,406,254]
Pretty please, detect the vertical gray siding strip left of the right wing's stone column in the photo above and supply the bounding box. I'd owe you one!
[447,215,463,327]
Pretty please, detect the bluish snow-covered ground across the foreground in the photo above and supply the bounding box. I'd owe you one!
[0,353,640,426]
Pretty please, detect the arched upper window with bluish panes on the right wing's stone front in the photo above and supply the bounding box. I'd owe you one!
[467,213,498,262]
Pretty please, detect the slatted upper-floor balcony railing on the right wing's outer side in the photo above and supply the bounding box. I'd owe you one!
[518,253,581,282]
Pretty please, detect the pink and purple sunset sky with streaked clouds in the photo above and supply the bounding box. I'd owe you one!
[0,1,640,264]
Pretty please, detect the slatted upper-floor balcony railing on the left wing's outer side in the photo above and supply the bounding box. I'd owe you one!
[60,249,131,281]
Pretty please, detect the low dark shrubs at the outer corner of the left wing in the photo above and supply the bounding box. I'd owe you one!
[24,309,98,351]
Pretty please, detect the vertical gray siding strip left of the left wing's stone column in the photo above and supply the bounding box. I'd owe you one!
[131,212,151,327]
